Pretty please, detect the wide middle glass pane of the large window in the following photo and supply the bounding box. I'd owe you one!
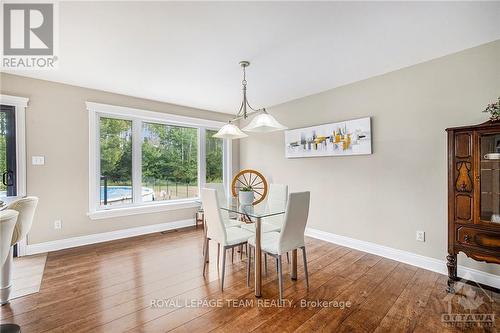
[142,123,198,201]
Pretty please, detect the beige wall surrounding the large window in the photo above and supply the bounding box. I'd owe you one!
[0,73,238,244]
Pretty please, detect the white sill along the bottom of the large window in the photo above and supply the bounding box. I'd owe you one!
[87,199,201,220]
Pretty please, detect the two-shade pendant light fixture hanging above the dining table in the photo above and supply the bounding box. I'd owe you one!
[214,61,287,140]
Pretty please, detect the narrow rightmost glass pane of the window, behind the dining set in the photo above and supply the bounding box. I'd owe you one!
[205,130,224,184]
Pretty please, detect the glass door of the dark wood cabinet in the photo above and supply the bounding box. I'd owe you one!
[479,133,500,223]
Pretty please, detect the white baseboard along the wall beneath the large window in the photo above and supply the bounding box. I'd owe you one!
[26,219,195,255]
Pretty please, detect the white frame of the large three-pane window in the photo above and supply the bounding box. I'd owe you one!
[86,102,232,219]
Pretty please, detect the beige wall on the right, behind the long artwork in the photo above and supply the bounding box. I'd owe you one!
[240,41,500,274]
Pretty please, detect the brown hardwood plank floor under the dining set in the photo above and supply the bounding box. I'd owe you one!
[0,229,500,333]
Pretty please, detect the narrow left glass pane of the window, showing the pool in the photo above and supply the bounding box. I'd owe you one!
[99,117,133,206]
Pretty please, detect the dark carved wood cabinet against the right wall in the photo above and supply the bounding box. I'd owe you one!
[446,121,500,292]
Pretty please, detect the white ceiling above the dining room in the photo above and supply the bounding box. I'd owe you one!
[6,2,500,113]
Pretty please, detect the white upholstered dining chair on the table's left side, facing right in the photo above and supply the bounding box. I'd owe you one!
[201,188,252,290]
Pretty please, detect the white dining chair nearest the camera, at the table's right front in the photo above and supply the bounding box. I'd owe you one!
[247,192,310,299]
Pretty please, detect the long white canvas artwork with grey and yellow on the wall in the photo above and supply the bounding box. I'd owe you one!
[285,117,372,158]
